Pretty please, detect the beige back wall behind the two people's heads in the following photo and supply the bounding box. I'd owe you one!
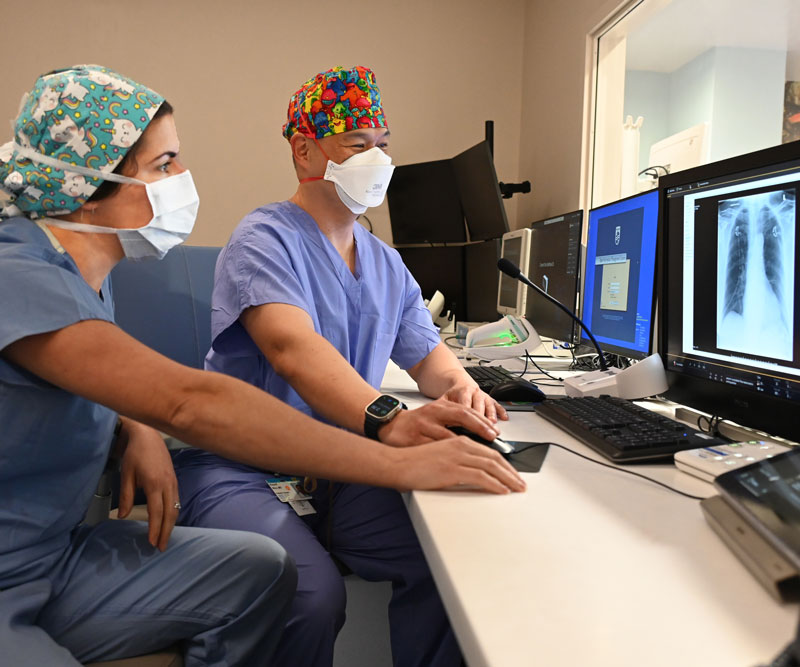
[0,0,524,245]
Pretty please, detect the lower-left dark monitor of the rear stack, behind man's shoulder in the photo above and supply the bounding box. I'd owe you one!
[397,246,467,321]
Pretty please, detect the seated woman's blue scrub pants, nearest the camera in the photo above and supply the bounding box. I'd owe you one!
[0,521,296,667]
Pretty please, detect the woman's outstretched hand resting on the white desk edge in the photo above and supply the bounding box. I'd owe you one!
[392,436,526,493]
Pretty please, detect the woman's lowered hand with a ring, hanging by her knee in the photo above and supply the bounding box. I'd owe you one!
[118,417,180,551]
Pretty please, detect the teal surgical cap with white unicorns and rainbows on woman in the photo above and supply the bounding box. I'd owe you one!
[0,65,164,219]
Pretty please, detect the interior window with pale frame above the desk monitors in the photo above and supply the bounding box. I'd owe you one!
[585,0,800,208]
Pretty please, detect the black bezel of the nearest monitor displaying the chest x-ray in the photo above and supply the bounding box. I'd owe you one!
[658,141,800,439]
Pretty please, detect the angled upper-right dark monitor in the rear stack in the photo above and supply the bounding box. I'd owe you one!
[453,141,508,241]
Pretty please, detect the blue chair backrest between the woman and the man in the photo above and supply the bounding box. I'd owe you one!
[111,245,220,368]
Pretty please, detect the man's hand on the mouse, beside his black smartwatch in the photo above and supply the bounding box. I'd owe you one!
[378,398,500,447]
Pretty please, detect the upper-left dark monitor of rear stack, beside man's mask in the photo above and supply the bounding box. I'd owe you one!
[386,160,467,245]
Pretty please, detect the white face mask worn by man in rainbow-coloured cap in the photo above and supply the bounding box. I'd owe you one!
[322,146,394,215]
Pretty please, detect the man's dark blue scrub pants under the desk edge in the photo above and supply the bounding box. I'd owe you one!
[175,450,462,667]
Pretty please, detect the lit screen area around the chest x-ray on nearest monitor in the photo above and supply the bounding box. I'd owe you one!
[669,168,800,390]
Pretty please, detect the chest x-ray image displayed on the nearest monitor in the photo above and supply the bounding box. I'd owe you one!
[717,188,796,360]
